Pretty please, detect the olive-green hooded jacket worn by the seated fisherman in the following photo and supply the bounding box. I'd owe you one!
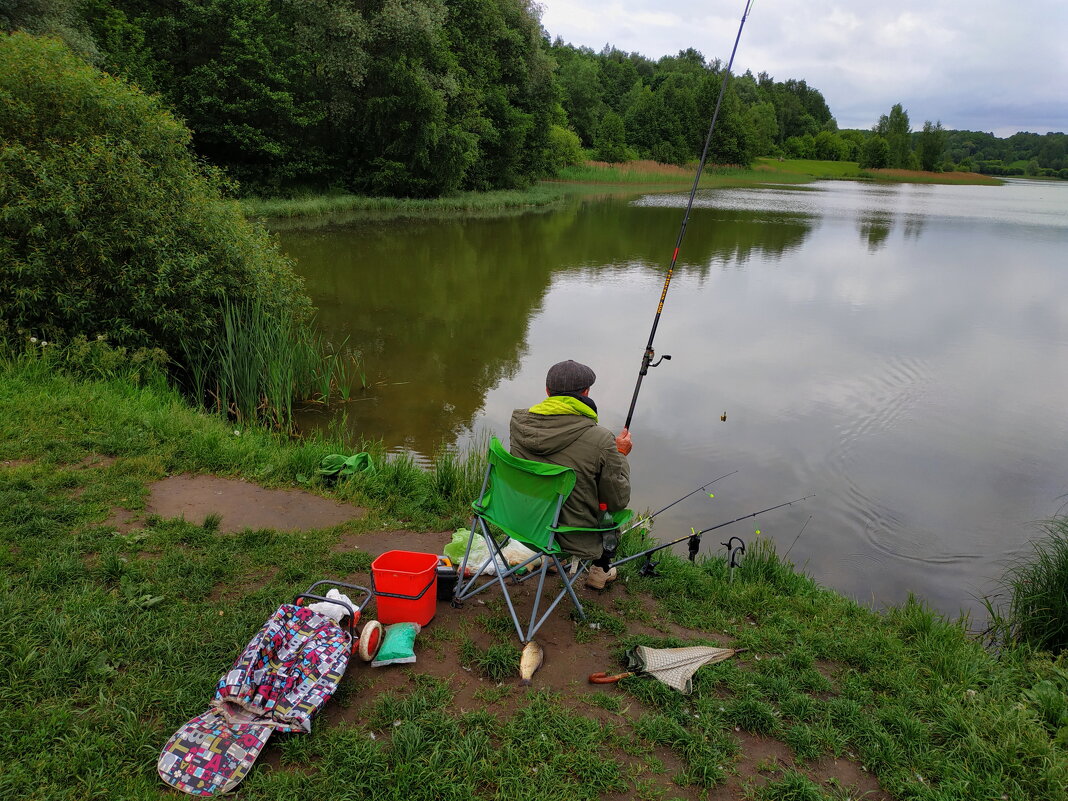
[509,395,630,559]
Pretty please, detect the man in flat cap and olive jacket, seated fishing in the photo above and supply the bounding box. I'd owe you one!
[509,359,632,590]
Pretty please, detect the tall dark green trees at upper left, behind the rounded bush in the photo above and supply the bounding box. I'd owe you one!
[0,0,569,195]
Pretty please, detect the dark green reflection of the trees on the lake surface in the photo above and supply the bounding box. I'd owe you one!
[281,199,812,454]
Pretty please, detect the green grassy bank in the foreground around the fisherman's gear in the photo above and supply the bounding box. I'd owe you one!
[0,357,1068,801]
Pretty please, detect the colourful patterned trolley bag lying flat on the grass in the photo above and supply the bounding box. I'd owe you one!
[157,603,352,796]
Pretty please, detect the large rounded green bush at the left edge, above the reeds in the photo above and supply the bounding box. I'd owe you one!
[0,33,311,358]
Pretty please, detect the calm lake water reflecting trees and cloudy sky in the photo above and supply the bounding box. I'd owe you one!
[280,180,1068,614]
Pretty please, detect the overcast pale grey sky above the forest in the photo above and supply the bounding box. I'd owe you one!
[538,0,1068,137]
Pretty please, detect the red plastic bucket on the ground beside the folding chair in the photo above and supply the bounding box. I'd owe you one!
[371,551,438,626]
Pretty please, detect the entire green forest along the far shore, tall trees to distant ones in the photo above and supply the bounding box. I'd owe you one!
[0,0,1068,198]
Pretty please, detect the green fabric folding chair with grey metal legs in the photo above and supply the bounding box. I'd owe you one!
[453,437,631,642]
